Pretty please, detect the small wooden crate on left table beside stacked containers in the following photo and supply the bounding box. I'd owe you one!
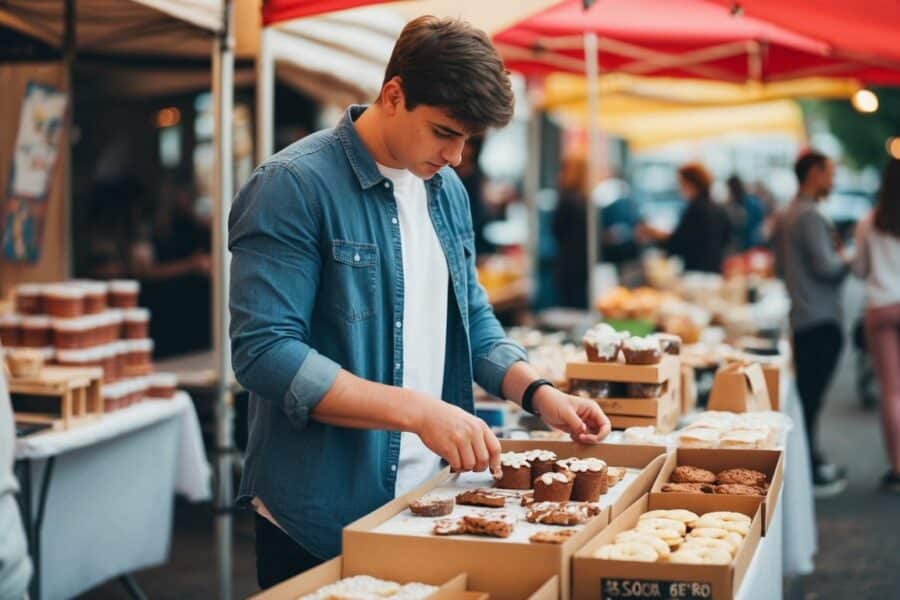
[9,366,103,429]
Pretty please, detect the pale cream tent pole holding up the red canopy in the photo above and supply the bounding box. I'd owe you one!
[584,32,602,310]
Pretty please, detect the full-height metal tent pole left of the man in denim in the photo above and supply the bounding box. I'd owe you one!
[212,0,234,600]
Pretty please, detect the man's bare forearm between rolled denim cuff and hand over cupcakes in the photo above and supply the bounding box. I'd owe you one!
[311,370,429,431]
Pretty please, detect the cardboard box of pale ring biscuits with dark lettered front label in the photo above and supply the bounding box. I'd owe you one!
[572,495,760,600]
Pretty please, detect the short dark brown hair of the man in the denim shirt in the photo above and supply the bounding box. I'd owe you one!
[384,15,514,134]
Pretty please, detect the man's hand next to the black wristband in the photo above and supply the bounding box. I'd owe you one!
[532,386,612,444]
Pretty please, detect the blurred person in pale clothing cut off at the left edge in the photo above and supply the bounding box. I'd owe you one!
[0,347,32,600]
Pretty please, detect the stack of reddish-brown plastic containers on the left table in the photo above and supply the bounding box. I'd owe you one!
[0,280,178,412]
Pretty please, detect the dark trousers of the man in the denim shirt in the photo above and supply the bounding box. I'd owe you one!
[254,514,325,590]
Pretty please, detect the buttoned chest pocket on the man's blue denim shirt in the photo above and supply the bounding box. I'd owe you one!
[326,240,378,321]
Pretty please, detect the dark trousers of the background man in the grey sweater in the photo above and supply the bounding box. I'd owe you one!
[794,323,844,466]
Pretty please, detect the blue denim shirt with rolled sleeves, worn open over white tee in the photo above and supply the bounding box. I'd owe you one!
[228,106,526,559]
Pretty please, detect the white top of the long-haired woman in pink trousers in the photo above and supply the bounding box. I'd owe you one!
[853,214,900,308]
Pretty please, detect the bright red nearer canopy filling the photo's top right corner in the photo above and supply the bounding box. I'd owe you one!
[710,0,900,71]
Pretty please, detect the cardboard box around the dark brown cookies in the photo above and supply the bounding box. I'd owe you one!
[650,448,784,535]
